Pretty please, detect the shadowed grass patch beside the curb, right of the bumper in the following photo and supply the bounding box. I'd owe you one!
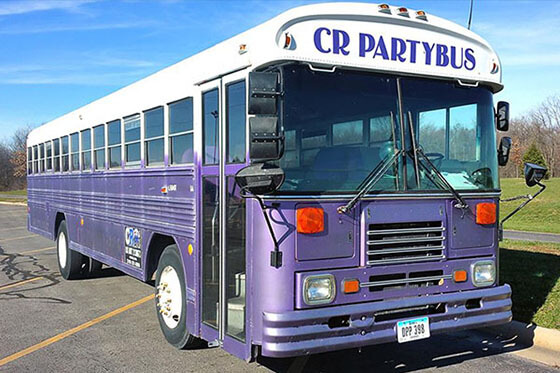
[500,240,560,330]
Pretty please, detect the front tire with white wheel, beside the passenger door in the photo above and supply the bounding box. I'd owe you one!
[155,245,199,349]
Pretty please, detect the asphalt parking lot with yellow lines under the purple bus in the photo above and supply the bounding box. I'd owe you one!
[0,205,557,373]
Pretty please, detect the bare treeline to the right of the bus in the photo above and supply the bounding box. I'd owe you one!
[500,96,560,177]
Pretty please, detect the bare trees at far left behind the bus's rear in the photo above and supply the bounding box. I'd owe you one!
[0,127,31,191]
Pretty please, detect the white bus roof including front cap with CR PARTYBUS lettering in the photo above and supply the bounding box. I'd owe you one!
[28,3,502,146]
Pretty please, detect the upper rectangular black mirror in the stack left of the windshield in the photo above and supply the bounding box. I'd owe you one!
[248,72,281,115]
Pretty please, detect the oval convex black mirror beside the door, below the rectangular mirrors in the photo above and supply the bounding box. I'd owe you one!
[235,163,285,194]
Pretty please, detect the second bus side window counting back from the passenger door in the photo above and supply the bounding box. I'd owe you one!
[144,106,164,166]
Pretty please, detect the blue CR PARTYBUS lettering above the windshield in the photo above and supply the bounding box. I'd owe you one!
[313,27,476,71]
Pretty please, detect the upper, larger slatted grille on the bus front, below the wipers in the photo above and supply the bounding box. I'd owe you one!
[367,221,445,265]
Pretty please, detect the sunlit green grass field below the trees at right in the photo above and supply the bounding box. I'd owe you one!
[500,178,560,233]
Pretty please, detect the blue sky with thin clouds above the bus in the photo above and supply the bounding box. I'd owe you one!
[0,0,560,141]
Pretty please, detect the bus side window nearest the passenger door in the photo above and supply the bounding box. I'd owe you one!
[168,97,194,165]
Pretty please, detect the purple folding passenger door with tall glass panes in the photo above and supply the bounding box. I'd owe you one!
[201,71,250,358]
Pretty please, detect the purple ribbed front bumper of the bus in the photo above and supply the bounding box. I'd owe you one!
[262,285,511,357]
